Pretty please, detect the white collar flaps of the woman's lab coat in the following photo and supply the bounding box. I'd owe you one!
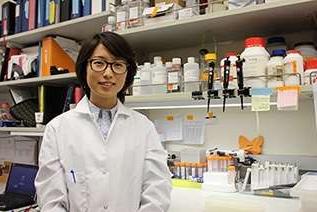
[74,95,132,117]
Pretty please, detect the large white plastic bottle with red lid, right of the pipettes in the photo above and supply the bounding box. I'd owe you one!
[241,37,270,88]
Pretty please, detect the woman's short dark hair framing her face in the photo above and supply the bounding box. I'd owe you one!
[76,32,137,103]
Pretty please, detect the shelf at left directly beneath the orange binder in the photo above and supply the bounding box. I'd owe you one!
[0,73,77,91]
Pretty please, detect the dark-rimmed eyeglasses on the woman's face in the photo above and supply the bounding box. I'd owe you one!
[88,59,128,74]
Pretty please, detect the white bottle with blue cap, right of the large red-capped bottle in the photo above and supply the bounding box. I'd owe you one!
[267,49,286,88]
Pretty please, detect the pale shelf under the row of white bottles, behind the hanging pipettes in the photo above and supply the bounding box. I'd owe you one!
[125,86,313,110]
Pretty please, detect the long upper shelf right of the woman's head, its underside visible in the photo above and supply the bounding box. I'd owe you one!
[120,0,317,51]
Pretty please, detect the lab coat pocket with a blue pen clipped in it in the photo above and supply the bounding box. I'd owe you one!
[66,170,88,212]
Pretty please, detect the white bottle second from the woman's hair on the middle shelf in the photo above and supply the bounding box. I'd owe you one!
[140,63,152,95]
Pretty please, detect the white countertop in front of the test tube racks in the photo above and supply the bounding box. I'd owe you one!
[168,188,300,212]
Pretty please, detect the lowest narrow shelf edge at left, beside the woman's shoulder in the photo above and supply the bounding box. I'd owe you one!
[0,127,44,137]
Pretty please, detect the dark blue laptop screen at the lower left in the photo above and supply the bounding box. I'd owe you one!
[6,163,38,197]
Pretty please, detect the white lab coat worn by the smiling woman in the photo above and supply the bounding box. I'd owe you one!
[35,97,171,212]
